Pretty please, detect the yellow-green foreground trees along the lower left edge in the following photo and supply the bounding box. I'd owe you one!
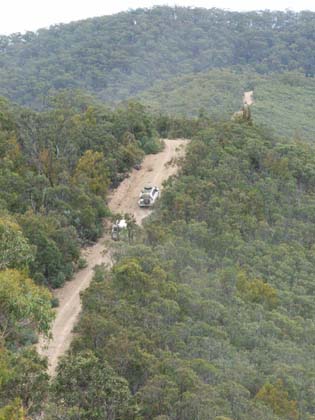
[0,262,54,420]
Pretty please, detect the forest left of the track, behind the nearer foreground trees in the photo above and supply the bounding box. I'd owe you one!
[0,92,161,287]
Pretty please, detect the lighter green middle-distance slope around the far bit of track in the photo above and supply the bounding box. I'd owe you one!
[137,69,315,140]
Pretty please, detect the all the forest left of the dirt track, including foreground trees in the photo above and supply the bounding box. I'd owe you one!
[0,93,161,420]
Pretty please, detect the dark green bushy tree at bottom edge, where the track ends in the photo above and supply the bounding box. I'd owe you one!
[49,352,135,420]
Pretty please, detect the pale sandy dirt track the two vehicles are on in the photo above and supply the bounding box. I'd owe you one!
[37,139,187,376]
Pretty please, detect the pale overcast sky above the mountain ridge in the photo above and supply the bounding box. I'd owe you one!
[0,0,315,35]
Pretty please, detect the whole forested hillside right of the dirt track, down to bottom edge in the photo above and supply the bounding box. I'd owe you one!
[43,120,315,420]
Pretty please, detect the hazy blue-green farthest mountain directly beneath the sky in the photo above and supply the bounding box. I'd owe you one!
[0,7,315,108]
